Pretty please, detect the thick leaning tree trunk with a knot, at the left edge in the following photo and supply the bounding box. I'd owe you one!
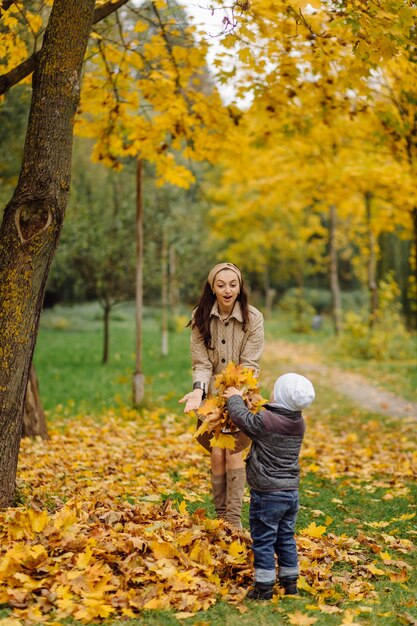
[0,0,94,507]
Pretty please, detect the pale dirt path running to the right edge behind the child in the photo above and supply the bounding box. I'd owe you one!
[263,341,417,419]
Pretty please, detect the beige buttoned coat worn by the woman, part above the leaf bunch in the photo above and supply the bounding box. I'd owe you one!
[191,301,264,393]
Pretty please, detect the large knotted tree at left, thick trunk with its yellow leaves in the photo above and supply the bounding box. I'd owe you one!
[0,0,231,505]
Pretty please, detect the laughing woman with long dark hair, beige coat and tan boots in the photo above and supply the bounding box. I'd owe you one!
[179,263,264,528]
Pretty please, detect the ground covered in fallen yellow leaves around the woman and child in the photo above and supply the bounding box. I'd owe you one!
[0,348,417,626]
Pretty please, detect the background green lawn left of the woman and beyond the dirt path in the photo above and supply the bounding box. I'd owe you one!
[34,303,417,415]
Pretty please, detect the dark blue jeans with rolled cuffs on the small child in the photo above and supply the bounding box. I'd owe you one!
[249,490,299,582]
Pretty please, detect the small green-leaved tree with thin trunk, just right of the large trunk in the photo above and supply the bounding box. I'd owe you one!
[53,143,135,363]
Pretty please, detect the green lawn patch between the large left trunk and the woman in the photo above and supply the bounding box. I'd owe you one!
[34,304,191,415]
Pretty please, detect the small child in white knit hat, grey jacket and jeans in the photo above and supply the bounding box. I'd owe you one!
[224,374,315,600]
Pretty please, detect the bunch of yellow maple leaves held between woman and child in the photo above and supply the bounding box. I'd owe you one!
[194,361,266,449]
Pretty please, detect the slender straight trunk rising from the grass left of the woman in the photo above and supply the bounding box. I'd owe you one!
[133,159,145,406]
